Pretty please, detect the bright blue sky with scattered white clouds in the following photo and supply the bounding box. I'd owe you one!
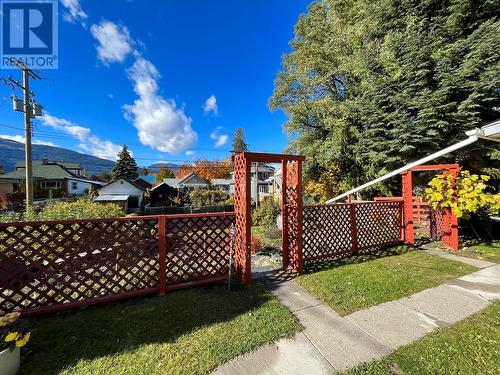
[0,0,310,165]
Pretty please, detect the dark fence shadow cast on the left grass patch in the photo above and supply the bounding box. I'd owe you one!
[21,284,272,374]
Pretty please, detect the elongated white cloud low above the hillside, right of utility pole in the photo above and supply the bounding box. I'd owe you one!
[42,113,122,160]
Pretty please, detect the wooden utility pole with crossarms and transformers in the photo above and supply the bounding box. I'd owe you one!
[9,60,42,212]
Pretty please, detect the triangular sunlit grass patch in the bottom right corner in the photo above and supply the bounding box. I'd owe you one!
[345,302,500,375]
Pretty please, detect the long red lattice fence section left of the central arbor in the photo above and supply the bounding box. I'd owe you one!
[0,213,234,315]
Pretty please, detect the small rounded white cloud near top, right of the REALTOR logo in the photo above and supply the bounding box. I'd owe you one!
[90,21,133,64]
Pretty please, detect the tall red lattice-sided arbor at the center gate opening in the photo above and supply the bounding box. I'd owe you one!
[234,152,304,284]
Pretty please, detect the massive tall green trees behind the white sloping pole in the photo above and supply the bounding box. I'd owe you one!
[270,0,500,198]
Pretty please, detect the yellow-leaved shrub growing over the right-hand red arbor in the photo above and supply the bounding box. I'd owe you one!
[424,171,500,219]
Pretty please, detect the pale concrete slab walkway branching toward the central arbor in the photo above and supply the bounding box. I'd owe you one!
[214,253,500,375]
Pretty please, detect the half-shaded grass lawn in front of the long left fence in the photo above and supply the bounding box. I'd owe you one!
[21,283,301,375]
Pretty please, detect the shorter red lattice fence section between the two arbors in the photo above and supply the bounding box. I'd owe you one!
[302,201,403,262]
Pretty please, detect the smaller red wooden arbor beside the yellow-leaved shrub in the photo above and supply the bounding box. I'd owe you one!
[401,164,460,251]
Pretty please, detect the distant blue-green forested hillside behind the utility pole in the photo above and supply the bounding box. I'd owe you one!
[0,138,115,174]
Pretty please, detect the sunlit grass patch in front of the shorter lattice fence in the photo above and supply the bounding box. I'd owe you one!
[296,248,476,315]
